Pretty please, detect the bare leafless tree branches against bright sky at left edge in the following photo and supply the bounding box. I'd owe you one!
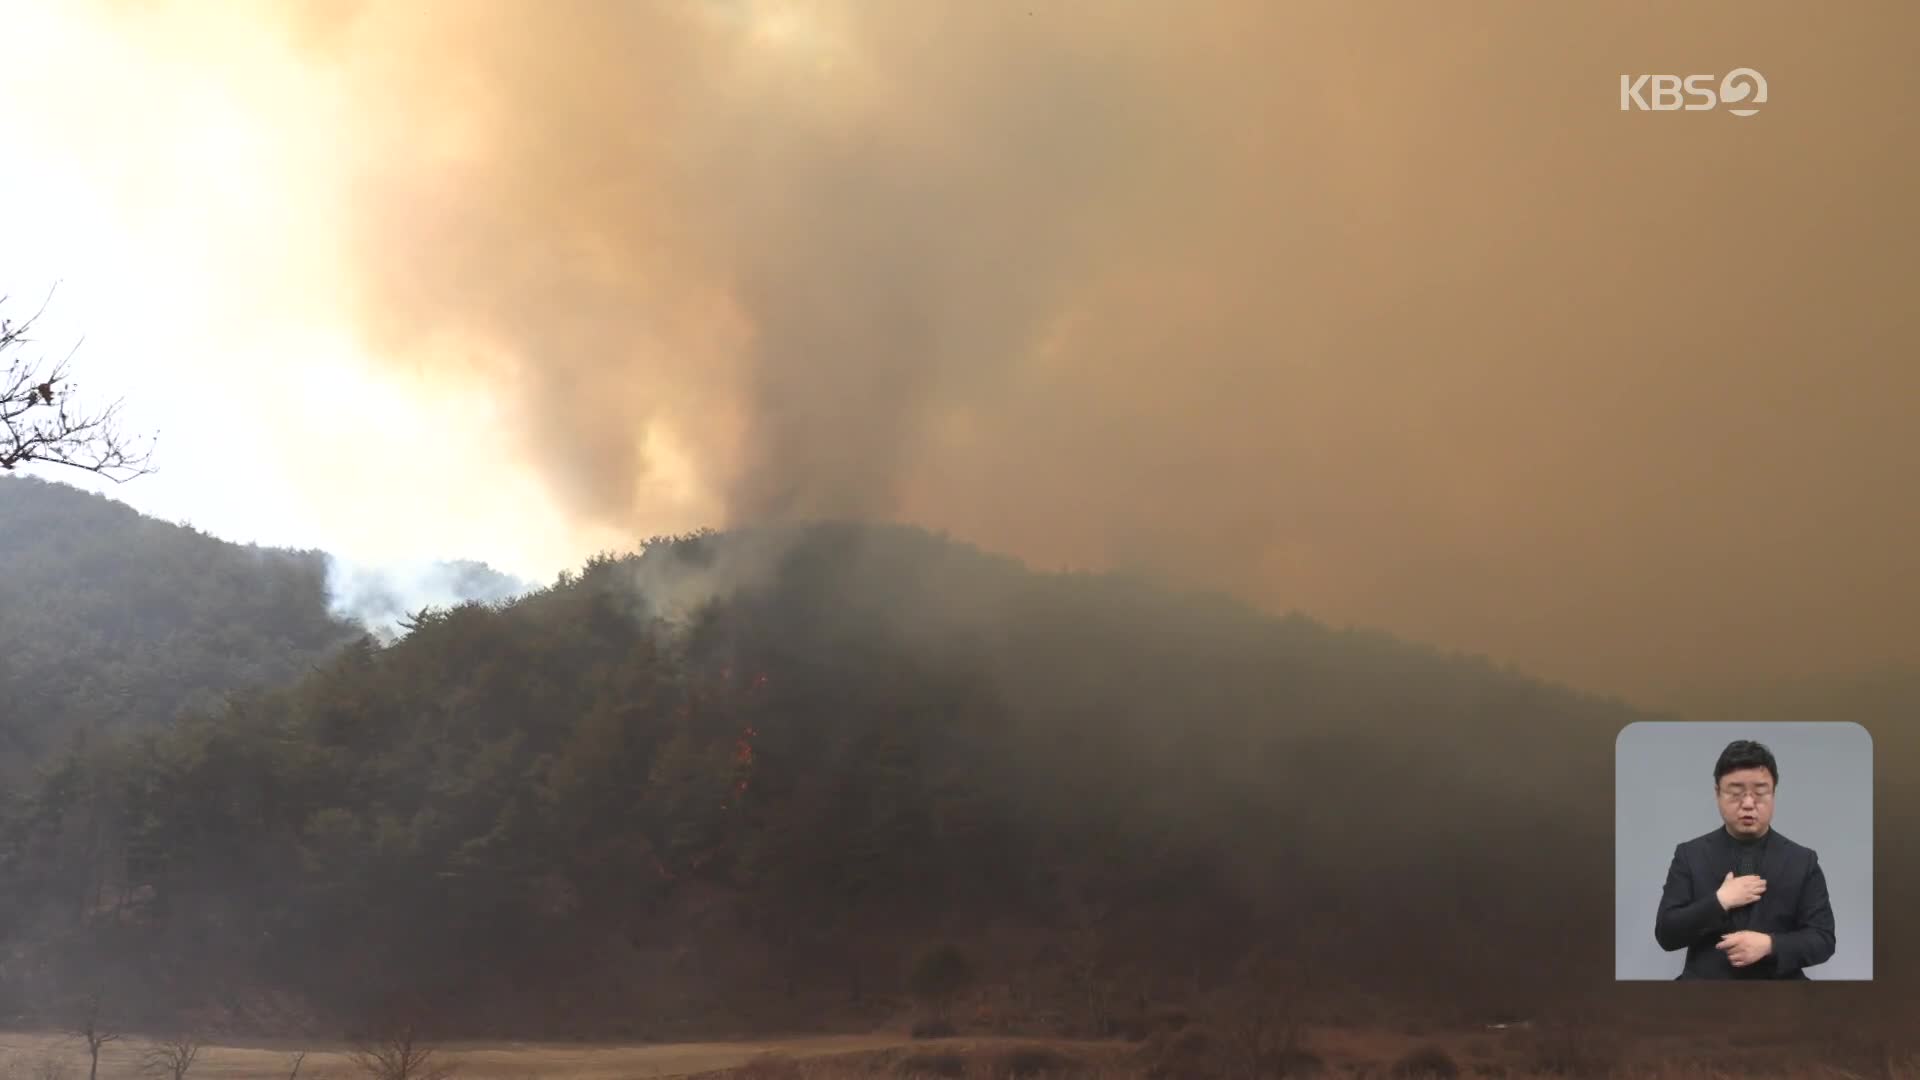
[0,296,152,482]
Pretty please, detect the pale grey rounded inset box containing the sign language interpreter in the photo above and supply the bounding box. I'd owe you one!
[1613,723,1874,980]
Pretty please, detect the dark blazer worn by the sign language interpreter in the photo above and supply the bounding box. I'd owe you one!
[1653,826,1834,978]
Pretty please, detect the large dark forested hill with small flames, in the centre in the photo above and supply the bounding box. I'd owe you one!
[0,527,1666,1036]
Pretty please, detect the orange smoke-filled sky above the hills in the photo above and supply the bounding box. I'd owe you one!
[0,0,1920,696]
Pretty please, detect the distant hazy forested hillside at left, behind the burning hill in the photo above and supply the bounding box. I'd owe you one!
[0,477,357,764]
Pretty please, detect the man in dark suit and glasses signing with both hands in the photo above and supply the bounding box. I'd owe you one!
[1653,740,1834,978]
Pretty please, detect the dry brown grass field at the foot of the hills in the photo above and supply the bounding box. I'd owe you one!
[0,1026,1920,1080]
